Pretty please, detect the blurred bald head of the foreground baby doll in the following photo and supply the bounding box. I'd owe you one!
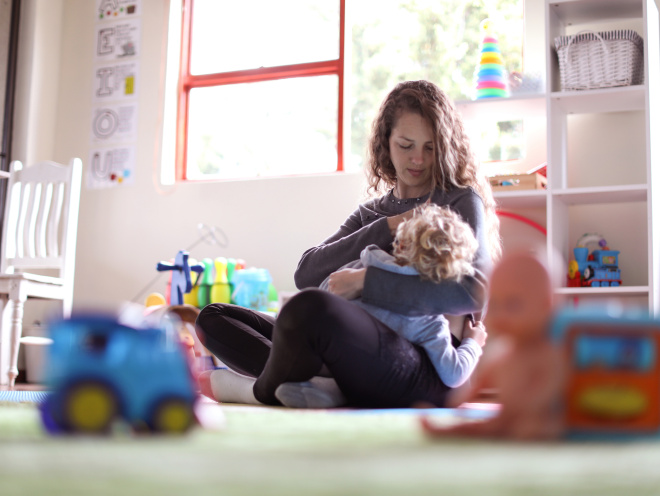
[486,253,552,342]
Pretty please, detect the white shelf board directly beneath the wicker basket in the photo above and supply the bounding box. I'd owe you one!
[550,85,646,114]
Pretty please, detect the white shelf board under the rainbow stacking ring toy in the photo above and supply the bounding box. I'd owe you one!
[456,93,545,121]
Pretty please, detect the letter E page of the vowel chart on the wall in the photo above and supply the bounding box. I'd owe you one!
[95,19,142,63]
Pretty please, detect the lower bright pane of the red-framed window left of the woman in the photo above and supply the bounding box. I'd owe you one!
[187,76,339,179]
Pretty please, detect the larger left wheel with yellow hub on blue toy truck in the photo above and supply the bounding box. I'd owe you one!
[64,382,118,433]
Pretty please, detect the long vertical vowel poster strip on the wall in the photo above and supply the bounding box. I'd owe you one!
[87,0,142,189]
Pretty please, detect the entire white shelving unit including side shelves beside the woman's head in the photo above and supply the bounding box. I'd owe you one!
[457,0,660,315]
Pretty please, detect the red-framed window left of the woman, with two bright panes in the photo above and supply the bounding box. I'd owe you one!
[177,0,344,179]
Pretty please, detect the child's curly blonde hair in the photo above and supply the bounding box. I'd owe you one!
[393,204,479,283]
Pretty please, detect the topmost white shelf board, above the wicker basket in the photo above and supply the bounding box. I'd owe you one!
[549,0,644,26]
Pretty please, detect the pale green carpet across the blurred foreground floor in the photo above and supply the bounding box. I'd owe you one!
[0,403,660,496]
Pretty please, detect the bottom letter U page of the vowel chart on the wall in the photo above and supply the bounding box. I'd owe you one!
[87,145,135,188]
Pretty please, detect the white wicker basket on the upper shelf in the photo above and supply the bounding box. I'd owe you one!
[555,29,644,91]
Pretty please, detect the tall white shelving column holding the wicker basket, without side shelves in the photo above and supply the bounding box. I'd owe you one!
[546,0,660,314]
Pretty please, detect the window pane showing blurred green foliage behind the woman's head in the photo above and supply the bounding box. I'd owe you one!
[346,0,523,169]
